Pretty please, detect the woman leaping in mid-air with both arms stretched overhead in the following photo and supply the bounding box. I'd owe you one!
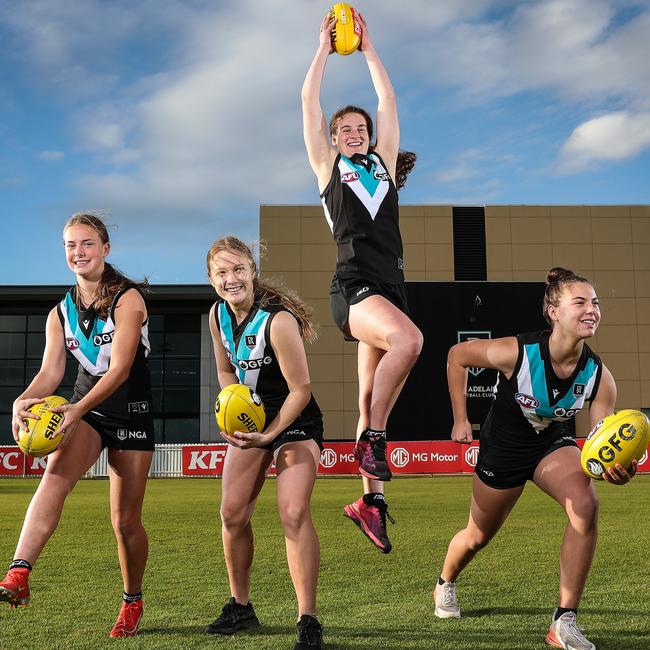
[302,8,422,553]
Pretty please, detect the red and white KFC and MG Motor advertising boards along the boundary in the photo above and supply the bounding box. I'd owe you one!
[0,439,650,478]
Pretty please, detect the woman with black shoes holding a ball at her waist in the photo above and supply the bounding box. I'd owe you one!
[206,237,323,650]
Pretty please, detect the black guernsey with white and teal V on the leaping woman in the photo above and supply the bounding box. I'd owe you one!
[321,151,404,284]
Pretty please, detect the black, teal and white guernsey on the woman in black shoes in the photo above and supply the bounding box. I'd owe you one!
[214,296,322,424]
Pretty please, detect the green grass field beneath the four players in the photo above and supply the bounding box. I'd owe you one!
[0,477,650,650]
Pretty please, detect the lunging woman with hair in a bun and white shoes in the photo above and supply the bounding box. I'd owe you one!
[434,268,636,650]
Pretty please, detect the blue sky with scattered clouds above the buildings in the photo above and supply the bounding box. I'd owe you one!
[0,0,650,284]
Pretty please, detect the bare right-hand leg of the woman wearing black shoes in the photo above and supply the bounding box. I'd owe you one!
[276,440,320,618]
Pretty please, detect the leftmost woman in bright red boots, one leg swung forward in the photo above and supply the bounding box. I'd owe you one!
[0,213,154,638]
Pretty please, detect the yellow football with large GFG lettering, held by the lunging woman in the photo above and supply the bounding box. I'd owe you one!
[580,409,650,479]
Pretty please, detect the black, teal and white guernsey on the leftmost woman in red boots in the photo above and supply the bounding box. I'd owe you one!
[57,287,152,420]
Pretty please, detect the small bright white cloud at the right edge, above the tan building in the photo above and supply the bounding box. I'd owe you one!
[559,111,650,172]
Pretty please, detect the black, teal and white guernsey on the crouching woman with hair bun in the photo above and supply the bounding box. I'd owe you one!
[481,331,603,451]
